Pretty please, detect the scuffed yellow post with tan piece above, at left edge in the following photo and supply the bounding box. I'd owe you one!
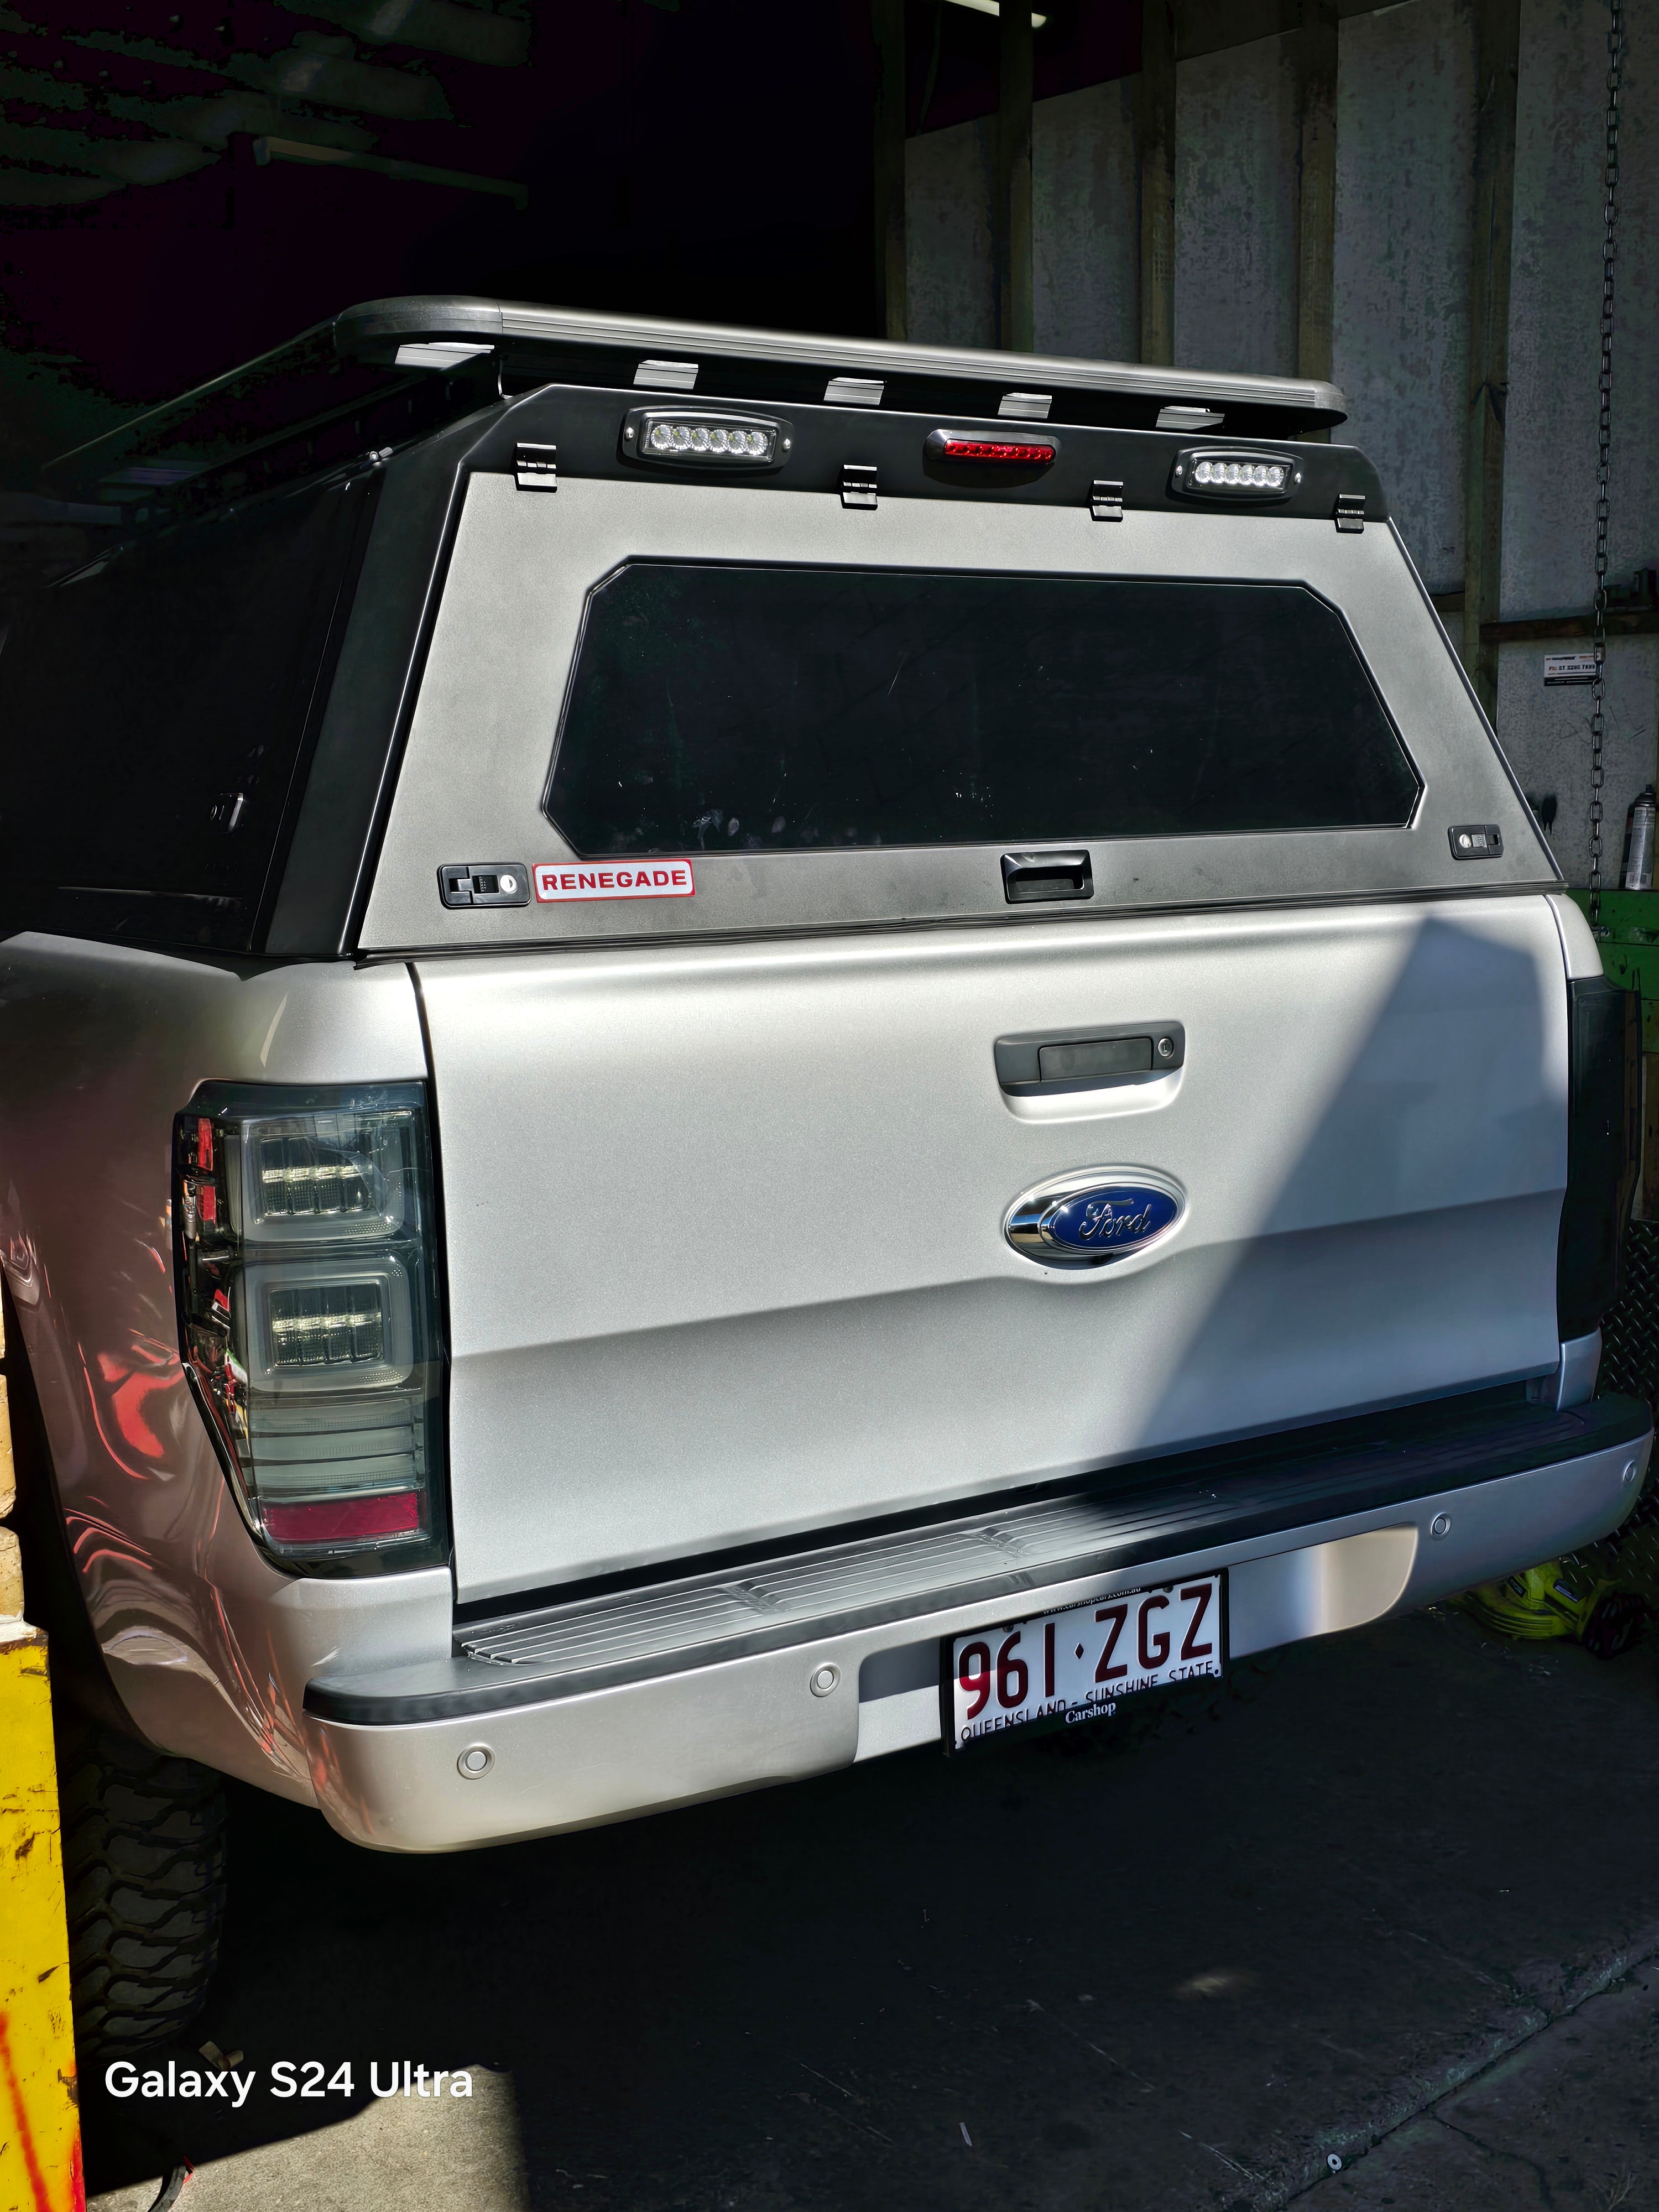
[0,1292,86,2212]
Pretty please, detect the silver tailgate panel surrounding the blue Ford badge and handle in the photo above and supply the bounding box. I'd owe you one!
[418,898,1566,1597]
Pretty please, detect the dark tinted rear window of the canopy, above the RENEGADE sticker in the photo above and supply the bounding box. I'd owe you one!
[549,562,1418,854]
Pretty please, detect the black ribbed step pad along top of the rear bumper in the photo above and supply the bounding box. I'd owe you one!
[305,1394,1652,1728]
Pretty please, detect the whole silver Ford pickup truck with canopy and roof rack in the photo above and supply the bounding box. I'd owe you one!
[0,299,1650,2046]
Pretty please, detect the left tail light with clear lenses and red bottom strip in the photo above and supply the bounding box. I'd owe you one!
[173,1084,442,1573]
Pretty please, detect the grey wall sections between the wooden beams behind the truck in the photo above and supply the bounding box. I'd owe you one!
[909,0,1659,880]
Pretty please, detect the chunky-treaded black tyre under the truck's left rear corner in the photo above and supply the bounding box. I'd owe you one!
[58,1723,226,2057]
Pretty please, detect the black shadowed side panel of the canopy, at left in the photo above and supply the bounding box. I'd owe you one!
[0,484,365,949]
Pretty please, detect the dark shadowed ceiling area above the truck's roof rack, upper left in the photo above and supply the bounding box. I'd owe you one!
[0,0,1139,487]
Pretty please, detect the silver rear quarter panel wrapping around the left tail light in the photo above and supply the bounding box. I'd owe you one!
[0,936,451,1803]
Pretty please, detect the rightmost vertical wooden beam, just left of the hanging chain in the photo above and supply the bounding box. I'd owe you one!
[1462,0,1520,719]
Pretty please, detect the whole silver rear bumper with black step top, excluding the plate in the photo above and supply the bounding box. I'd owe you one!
[305,1398,1652,1851]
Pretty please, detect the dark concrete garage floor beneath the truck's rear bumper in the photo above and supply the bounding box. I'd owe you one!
[84,1610,1659,2212]
